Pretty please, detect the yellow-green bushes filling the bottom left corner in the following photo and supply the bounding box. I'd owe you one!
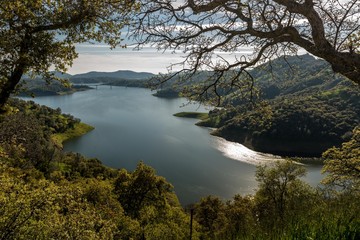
[0,164,126,239]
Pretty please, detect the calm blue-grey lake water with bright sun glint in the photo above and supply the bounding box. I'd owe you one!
[25,86,322,205]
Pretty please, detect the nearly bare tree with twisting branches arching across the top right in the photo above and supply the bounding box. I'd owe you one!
[132,0,360,99]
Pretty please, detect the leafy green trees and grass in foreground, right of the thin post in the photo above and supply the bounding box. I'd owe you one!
[190,161,360,240]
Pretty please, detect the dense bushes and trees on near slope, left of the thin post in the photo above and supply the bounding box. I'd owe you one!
[0,111,196,239]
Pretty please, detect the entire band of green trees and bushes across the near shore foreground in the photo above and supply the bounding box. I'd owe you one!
[0,99,360,239]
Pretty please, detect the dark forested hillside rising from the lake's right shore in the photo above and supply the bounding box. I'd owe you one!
[199,55,360,156]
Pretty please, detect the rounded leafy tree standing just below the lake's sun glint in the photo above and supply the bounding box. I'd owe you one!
[255,160,311,231]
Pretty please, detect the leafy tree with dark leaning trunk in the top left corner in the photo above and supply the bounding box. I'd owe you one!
[0,0,137,107]
